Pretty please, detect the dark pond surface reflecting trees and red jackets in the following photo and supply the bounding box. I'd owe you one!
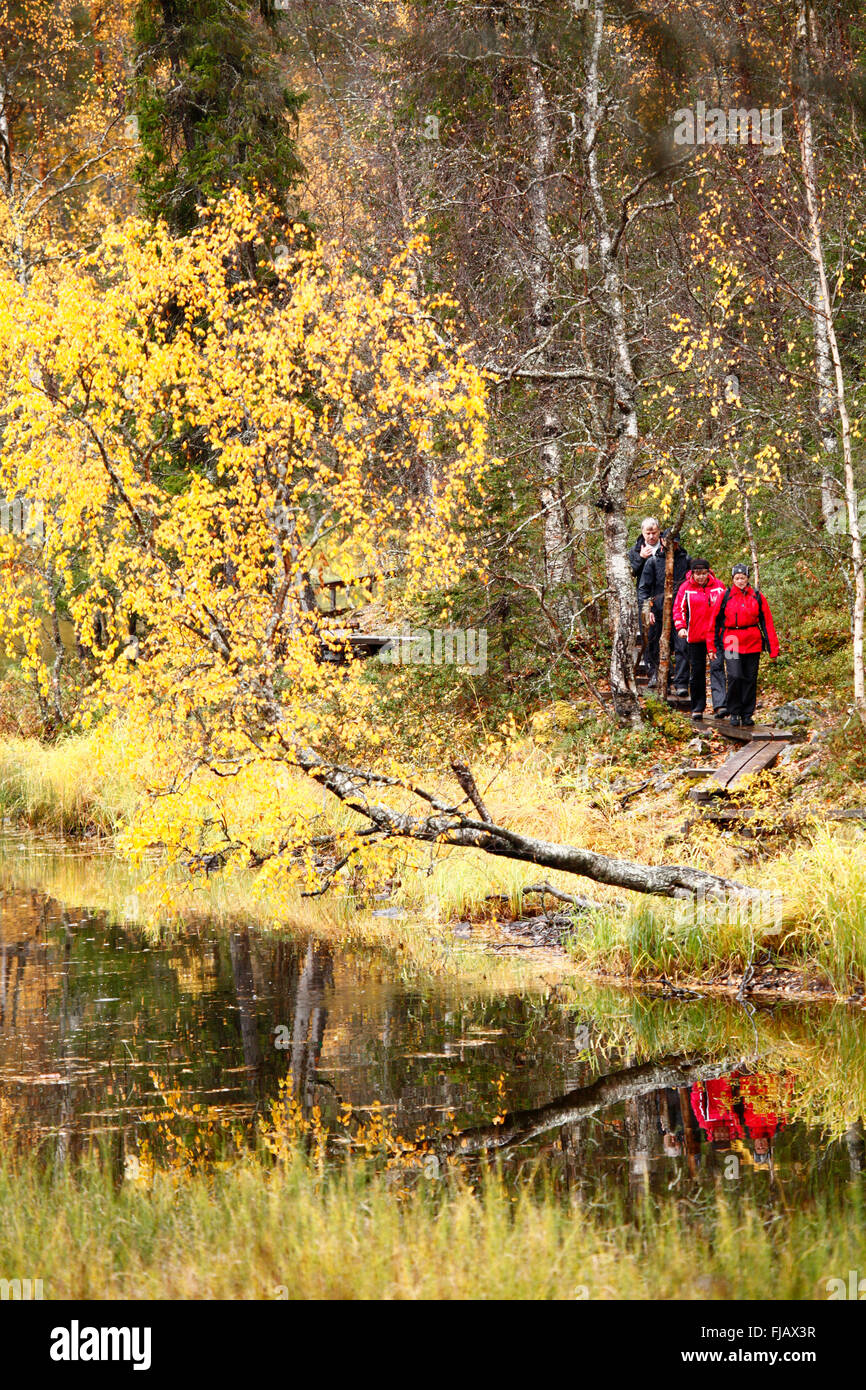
[0,834,866,1200]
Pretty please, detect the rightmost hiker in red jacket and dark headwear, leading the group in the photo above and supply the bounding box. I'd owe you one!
[710,564,778,724]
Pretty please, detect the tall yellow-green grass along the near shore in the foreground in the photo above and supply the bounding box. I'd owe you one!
[0,1156,866,1300]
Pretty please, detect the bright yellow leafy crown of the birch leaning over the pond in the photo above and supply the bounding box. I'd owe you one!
[0,193,487,890]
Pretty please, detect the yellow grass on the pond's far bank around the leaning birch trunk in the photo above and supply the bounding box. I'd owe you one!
[0,727,866,991]
